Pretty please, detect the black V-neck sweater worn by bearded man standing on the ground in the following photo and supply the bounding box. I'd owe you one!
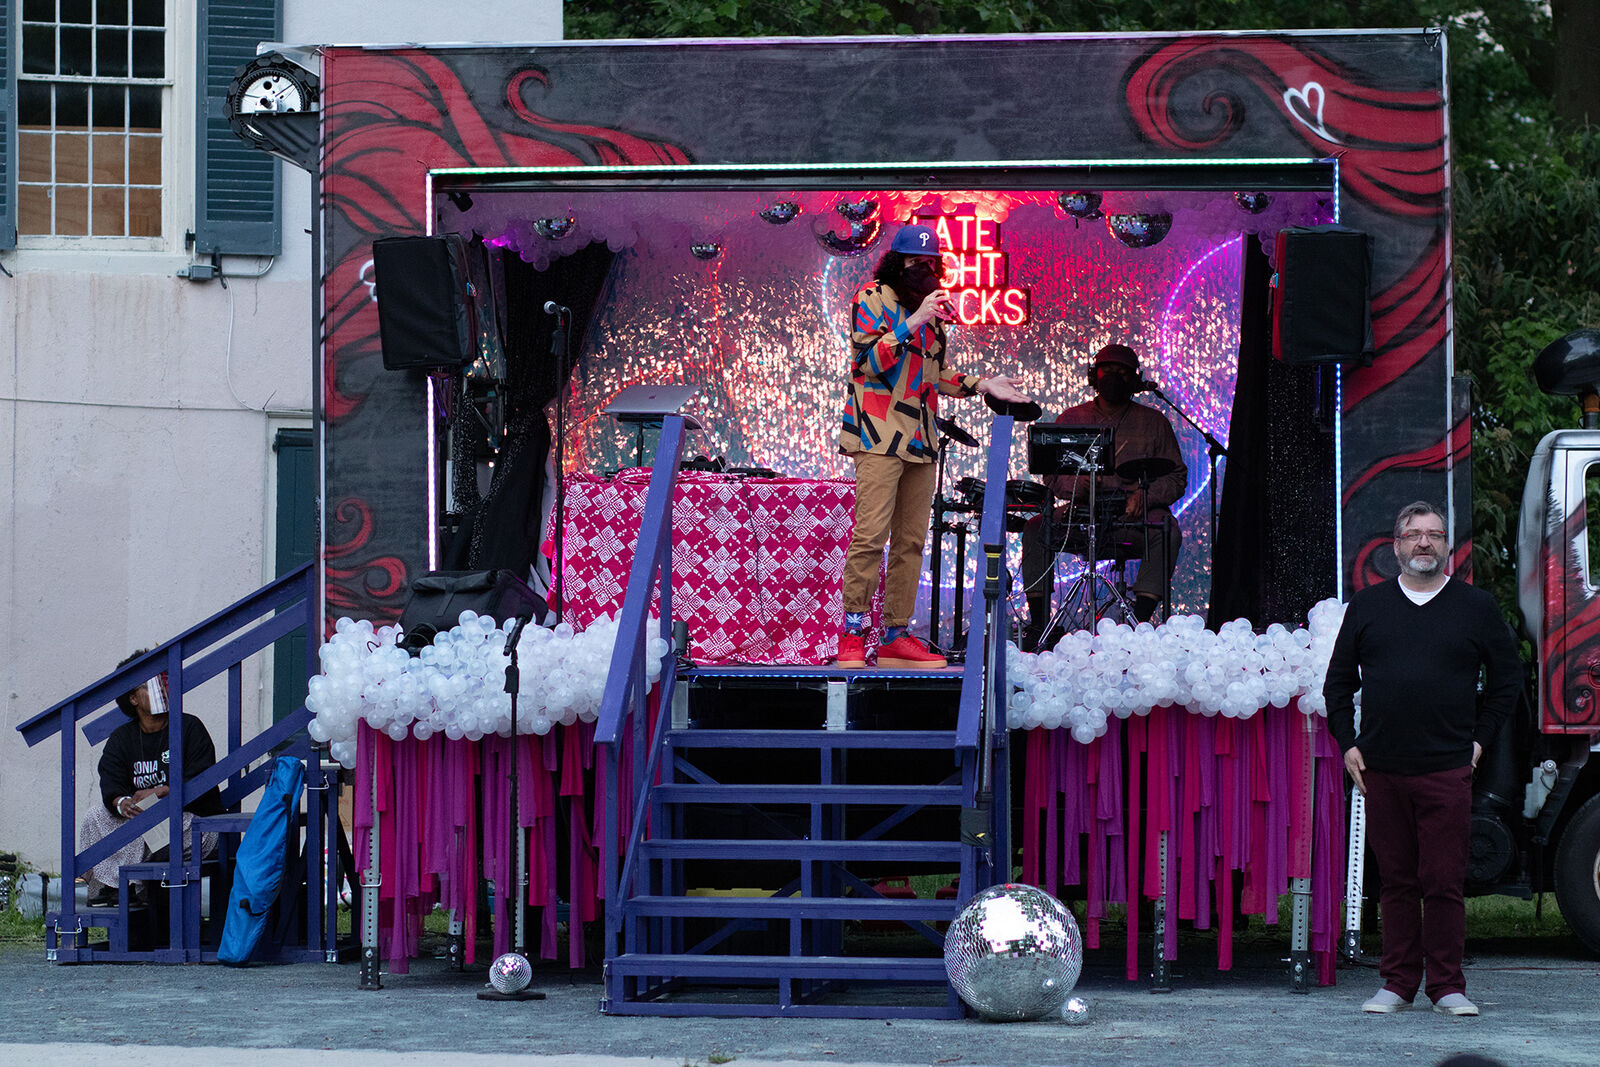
[1322,579,1522,774]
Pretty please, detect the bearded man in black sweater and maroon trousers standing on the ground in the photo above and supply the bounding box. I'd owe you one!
[1322,502,1522,1016]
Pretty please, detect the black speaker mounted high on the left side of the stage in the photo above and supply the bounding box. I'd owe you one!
[373,234,477,371]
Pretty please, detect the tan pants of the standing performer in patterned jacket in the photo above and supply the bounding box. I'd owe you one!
[845,453,936,625]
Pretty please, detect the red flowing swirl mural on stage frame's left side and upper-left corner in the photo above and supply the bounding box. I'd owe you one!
[322,50,690,621]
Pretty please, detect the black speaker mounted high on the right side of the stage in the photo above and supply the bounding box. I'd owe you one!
[1272,226,1373,365]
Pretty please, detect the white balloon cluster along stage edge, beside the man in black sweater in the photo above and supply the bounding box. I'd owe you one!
[1006,600,1344,744]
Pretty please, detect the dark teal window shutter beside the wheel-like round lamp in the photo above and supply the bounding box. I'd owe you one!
[194,0,283,256]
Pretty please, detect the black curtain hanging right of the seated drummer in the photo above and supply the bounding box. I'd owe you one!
[1206,235,1339,629]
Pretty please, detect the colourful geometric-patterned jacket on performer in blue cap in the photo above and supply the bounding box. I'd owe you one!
[838,282,981,462]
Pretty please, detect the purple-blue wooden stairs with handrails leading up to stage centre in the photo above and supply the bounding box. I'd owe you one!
[595,416,1011,1019]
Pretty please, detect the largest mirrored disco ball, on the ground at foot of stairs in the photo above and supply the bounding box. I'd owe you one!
[944,885,1083,1022]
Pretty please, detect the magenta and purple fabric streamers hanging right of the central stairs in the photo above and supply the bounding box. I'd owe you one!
[1021,704,1344,985]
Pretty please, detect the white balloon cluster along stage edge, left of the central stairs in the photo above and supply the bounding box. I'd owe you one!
[306,611,669,766]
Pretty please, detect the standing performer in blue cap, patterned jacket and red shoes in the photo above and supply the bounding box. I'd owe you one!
[837,226,1027,670]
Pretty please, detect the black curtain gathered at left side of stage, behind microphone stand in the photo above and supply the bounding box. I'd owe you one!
[445,242,616,574]
